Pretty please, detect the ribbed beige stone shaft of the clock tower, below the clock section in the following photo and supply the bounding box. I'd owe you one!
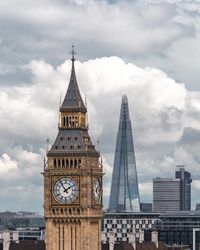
[45,219,101,250]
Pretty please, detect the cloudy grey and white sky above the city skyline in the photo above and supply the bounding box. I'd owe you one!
[0,0,200,214]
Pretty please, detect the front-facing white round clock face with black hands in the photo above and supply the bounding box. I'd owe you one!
[53,177,79,204]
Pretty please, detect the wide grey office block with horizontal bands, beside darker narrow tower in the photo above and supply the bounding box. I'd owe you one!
[153,177,180,213]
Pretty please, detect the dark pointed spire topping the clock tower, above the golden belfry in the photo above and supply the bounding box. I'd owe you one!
[60,45,87,112]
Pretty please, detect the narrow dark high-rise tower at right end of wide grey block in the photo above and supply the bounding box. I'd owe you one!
[175,165,192,211]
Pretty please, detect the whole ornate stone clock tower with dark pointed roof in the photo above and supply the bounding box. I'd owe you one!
[44,48,102,250]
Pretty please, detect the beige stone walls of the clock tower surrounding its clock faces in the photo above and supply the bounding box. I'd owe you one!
[44,153,102,250]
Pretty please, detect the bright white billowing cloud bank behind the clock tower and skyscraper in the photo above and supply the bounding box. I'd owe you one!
[0,57,200,209]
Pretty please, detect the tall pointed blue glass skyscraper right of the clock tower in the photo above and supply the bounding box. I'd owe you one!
[109,95,140,212]
